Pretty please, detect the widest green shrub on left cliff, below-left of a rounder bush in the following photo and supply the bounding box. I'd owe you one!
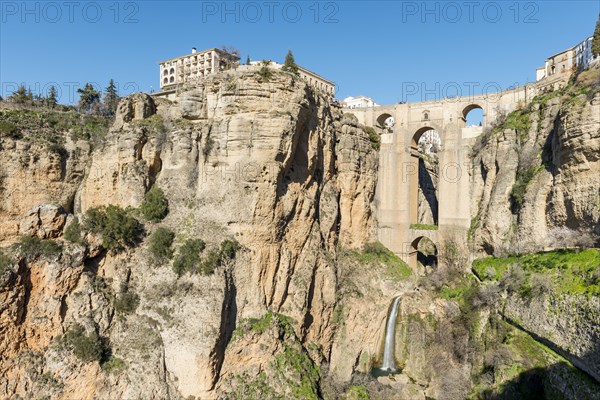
[84,205,144,253]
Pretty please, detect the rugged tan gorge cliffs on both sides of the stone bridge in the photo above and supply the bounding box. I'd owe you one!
[0,64,600,399]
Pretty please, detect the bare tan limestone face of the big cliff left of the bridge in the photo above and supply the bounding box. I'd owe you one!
[0,71,377,398]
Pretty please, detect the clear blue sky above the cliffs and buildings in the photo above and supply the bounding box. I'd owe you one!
[0,0,600,104]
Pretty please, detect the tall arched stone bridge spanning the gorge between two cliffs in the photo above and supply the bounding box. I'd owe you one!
[344,85,537,268]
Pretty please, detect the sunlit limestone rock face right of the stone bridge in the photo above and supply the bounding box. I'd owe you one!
[471,68,600,254]
